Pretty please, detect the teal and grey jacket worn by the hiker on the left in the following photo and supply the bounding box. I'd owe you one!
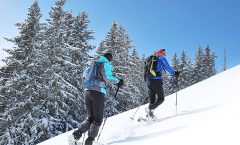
[85,56,119,95]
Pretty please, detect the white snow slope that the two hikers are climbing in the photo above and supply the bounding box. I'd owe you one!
[39,65,240,145]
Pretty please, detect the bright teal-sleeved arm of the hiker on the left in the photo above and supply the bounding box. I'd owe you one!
[101,63,119,84]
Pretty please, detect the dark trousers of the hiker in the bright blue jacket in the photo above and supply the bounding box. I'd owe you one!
[148,80,164,110]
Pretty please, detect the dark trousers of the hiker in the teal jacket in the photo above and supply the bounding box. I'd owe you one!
[79,90,104,139]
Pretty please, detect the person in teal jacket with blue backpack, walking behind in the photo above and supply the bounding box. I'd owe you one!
[73,53,123,145]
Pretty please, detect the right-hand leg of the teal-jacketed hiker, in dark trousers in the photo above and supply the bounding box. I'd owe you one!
[88,92,104,140]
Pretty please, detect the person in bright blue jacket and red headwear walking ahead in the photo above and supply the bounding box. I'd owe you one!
[146,49,179,117]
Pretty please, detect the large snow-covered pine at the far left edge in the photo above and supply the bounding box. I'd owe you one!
[0,1,47,144]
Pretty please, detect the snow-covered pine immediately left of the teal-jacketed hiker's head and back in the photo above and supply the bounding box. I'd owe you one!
[63,12,94,124]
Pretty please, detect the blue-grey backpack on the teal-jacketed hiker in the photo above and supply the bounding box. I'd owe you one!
[83,61,106,88]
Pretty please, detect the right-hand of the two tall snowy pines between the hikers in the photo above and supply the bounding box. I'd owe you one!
[111,26,139,112]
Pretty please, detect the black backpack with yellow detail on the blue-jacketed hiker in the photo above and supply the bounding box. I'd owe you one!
[144,55,161,81]
